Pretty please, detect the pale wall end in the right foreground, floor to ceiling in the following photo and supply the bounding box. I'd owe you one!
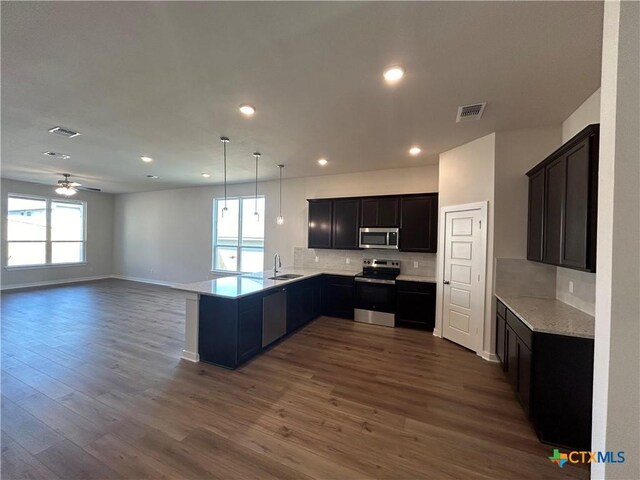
[591,1,640,479]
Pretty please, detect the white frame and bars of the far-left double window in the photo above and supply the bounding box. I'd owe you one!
[3,193,88,270]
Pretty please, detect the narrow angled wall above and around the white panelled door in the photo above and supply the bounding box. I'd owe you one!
[436,133,496,358]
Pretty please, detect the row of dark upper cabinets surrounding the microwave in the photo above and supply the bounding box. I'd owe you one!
[308,193,438,253]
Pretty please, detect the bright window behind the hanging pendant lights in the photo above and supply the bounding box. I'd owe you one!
[212,197,264,272]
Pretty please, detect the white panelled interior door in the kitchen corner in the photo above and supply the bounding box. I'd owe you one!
[442,208,486,351]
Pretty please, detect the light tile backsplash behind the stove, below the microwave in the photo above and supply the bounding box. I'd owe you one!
[293,247,436,277]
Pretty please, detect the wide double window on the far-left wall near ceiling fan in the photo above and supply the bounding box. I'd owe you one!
[7,195,86,267]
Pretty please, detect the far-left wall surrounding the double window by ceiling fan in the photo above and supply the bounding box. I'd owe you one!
[1,178,114,288]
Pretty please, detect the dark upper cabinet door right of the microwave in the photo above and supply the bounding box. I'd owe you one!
[400,194,438,253]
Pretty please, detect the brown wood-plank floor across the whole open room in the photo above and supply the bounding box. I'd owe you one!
[2,280,589,480]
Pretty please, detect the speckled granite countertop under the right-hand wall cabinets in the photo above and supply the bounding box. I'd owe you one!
[496,293,595,338]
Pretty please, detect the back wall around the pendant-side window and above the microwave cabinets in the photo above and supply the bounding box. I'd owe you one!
[114,165,438,283]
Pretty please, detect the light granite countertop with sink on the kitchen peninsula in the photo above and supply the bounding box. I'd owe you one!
[173,268,357,298]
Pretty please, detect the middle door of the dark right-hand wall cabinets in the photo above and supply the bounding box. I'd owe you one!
[544,157,567,265]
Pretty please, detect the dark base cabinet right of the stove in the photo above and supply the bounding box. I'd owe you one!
[395,280,436,330]
